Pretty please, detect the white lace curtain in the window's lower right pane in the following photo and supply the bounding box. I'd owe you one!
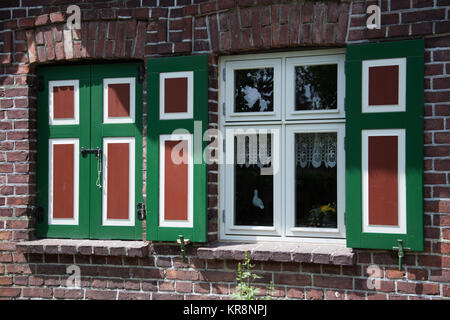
[295,133,337,168]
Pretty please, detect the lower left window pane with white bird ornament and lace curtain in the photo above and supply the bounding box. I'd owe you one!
[234,135,273,226]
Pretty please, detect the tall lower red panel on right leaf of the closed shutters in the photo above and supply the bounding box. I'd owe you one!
[107,143,130,219]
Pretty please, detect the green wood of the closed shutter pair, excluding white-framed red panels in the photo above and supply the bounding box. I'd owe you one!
[36,62,143,240]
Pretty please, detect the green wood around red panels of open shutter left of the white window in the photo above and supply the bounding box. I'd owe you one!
[147,55,208,242]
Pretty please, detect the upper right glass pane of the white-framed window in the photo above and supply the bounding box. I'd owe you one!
[295,64,337,111]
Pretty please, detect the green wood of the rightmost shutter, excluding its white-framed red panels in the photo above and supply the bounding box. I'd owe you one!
[346,40,424,251]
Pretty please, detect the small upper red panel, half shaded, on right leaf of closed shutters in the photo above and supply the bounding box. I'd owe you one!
[108,83,130,118]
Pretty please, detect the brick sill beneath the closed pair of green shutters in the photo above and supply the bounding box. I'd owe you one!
[16,239,150,257]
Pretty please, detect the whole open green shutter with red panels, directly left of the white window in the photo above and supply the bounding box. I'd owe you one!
[147,56,208,242]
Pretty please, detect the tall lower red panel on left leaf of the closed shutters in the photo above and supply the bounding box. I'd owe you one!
[52,144,74,219]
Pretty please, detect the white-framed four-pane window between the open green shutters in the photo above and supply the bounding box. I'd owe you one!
[221,50,345,241]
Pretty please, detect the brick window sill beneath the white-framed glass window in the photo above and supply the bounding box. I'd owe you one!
[197,242,356,266]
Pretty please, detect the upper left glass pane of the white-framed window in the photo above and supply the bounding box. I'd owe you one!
[234,68,274,112]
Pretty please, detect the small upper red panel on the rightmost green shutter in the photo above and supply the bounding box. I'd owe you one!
[369,66,399,106]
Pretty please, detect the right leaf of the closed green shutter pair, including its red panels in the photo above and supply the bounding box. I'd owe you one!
[90,62,143,240]
